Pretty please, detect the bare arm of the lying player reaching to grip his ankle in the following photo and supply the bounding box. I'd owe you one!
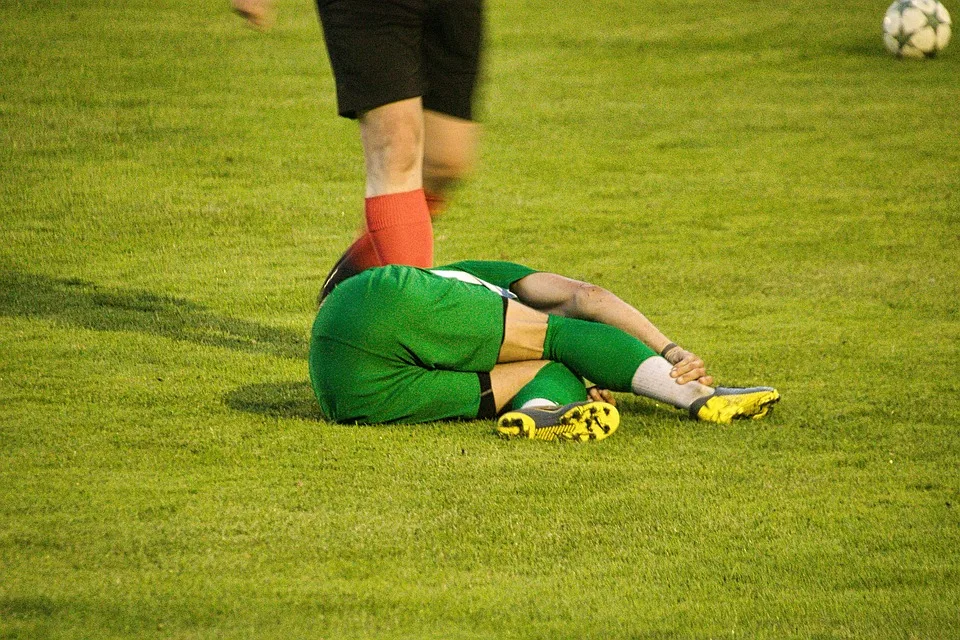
[510,273,713,385]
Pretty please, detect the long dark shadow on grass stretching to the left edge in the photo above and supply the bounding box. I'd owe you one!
[0,271,308,360]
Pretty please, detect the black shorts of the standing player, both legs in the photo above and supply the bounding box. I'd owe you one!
[317,0,483,120]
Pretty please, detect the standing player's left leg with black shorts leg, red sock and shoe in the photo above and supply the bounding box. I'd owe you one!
[317,0,433,299]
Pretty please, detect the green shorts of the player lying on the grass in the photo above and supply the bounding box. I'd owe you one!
[310,265,506,424]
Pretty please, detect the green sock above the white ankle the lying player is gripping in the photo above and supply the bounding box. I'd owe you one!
[543,316,657,391]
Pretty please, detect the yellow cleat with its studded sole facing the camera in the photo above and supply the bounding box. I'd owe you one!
[497,400,620,442]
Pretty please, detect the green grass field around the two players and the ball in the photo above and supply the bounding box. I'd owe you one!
[0,0,960,639]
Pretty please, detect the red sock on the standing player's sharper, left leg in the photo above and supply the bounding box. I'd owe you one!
[365,189,433,267]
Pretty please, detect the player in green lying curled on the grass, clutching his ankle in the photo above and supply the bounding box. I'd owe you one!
[310,261,780,440]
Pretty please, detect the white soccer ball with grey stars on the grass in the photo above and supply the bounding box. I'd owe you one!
[883,0,950,58]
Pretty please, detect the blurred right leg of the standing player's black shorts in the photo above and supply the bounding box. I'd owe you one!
[423,0,484,120]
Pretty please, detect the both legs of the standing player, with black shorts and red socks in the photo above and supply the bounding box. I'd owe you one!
[317,0,484,300]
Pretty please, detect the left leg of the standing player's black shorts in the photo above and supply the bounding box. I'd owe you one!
[317,0,426,118]
